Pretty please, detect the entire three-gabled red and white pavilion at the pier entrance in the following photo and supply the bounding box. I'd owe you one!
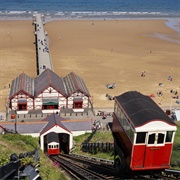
[9,69,90,114]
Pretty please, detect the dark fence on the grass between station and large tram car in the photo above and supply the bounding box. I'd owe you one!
[81,142,114,154]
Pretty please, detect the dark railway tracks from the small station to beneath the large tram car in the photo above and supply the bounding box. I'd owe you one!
[50,154,180,180]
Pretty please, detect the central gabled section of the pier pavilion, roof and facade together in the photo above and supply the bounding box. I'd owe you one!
[34,69,67,113]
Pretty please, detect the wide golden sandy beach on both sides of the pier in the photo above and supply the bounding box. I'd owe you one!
[0,19,180,109]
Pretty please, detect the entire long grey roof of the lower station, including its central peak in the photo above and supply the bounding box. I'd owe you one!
[0,114,93,135]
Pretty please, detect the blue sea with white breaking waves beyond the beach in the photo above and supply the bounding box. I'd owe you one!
[0,0,180,20]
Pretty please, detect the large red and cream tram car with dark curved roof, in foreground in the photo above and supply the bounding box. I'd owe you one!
[112,91,176,172]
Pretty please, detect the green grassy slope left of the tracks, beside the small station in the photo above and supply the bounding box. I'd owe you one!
[0,134,68,180]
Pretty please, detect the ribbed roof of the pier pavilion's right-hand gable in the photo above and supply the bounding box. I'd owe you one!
[63,72,90,97]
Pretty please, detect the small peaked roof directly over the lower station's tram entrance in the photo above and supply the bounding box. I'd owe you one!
[40,113,71,135]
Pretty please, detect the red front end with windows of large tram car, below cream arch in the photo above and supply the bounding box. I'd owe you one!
[131,130,175,170]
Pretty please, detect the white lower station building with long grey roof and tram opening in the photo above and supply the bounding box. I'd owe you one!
[0,113,93,153]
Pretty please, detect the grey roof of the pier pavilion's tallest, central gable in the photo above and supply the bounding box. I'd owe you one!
[34,69,66,96]
